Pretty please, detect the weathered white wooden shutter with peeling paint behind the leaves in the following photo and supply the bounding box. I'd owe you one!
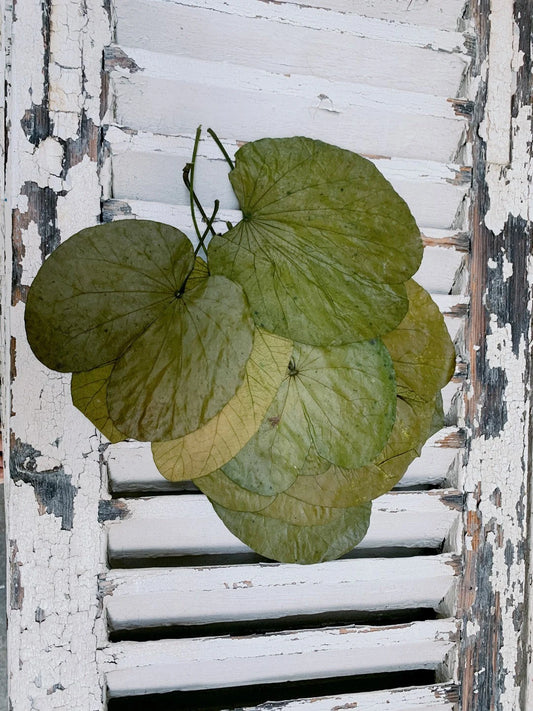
[3,0,532,711]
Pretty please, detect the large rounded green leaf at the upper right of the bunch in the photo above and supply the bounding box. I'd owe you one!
[208,137,422,346]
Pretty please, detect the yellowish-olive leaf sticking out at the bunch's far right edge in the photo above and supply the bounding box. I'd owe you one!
[383,279,455,401]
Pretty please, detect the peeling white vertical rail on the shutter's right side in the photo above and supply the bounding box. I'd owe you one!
[458,0,533,711]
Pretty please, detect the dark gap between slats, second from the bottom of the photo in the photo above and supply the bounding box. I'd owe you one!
[109,607,438,642]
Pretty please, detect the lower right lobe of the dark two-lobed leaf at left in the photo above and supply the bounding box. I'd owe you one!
[107,269,253,442]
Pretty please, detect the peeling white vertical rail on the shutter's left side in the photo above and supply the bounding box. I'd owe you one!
[2,0,110,711]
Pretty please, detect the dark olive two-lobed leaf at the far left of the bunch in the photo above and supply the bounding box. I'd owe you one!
[26,220,253,441]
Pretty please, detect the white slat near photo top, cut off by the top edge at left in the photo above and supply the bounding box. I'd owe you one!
[115,0,470,98]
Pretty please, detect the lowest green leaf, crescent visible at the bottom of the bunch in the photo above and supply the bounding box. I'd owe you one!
[211,502,371,565]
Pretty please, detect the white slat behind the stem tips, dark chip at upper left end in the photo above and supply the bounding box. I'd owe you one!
[111,47,466,162]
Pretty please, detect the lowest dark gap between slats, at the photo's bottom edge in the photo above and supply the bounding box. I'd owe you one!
[108,662,436,711]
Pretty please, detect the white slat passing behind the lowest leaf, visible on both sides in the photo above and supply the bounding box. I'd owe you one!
[108,490,458,559]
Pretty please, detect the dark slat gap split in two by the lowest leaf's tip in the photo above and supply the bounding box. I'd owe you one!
[108,545,442,569]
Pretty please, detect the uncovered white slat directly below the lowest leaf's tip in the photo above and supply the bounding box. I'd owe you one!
[105,554,457,630]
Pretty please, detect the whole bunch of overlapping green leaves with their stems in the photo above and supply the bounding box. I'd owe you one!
[26,130,455,563]
